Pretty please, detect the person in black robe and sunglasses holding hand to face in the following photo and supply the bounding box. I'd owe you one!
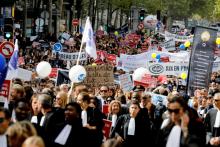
[156,96,206,147]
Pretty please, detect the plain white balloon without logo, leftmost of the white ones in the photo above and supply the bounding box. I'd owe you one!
[36,61,52,78]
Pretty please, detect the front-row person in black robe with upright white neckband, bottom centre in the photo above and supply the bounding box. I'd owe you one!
[110,100,153,147]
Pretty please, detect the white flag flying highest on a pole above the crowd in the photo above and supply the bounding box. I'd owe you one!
[82,17,97,59]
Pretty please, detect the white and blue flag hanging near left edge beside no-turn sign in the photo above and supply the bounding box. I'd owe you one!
[6,39,18,80]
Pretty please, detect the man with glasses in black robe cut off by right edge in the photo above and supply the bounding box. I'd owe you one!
[205,93,220,146]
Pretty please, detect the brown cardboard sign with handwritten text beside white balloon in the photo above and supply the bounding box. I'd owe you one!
[83,64,114,87]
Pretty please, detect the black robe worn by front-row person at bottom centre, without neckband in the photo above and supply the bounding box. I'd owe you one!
[110,109,154,147]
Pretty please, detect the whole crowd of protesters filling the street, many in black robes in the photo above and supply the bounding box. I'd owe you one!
[0,26,220,147]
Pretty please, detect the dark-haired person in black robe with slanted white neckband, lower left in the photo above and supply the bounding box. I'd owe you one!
[53,102,86,147]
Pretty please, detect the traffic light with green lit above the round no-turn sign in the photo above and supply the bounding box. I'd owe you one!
[4,18,14,40]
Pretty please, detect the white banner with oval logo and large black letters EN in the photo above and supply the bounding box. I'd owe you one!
[147,62,189,76]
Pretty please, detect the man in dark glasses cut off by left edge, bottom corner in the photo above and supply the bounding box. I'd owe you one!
[0,107,11,147]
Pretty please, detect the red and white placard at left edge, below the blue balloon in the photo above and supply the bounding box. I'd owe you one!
[0,80,11,107]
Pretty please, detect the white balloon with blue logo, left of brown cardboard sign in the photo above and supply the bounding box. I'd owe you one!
[69,65,86,83]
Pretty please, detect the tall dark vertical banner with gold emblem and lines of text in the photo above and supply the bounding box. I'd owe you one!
[187,26,217,96]
